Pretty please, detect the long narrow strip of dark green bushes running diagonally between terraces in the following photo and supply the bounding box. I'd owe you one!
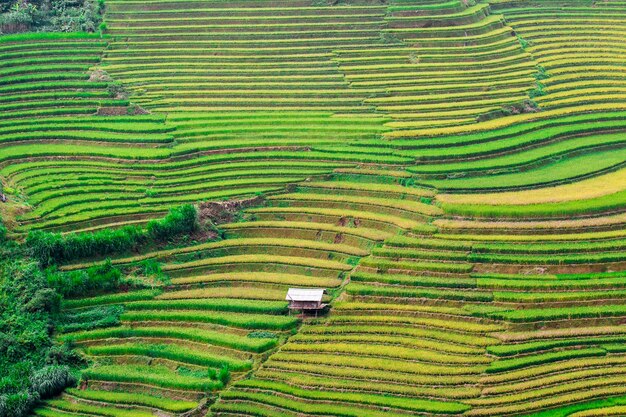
[26,205,198,267]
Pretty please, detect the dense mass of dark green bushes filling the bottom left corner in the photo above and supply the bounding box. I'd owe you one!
[0,260,82,417]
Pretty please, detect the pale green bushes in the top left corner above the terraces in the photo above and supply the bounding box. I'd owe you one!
[0,0,104,34]
